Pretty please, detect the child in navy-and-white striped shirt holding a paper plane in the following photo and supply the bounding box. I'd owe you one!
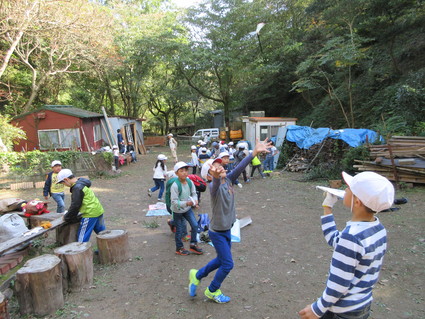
[298,172,394,319]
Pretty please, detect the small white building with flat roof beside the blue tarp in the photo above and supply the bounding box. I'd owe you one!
[242,116,298,145]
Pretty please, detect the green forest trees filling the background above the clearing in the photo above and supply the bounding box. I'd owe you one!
[0,0,425,135]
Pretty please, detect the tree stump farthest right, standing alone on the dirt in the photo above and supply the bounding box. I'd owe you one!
[96,230,130,264]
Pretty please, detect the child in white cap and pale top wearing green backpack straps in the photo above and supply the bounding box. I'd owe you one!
[170,162,203,256]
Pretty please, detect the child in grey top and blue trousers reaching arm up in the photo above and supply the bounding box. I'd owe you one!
[189,140,268,303]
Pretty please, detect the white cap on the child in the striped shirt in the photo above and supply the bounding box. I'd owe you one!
[342,172,394,213]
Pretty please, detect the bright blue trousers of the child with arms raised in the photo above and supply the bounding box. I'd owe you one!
[196,229,233,292]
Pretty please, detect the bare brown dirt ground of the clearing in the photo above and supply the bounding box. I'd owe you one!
[0,147,425,319]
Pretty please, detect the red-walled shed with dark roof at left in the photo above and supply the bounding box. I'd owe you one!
[11,105,143,152]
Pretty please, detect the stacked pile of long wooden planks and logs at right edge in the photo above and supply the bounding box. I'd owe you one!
[354,136,425,184]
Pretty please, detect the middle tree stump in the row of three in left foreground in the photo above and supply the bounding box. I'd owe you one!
[55,242,93,292]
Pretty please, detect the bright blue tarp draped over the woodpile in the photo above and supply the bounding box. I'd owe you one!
[286,125,383,149]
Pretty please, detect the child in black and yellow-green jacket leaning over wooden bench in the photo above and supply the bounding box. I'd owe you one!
[57,168,106,243]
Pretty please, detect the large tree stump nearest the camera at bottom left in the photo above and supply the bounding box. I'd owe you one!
[15,254,64,316]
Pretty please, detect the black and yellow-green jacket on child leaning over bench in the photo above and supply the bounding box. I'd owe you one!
[65,178,104,221]
